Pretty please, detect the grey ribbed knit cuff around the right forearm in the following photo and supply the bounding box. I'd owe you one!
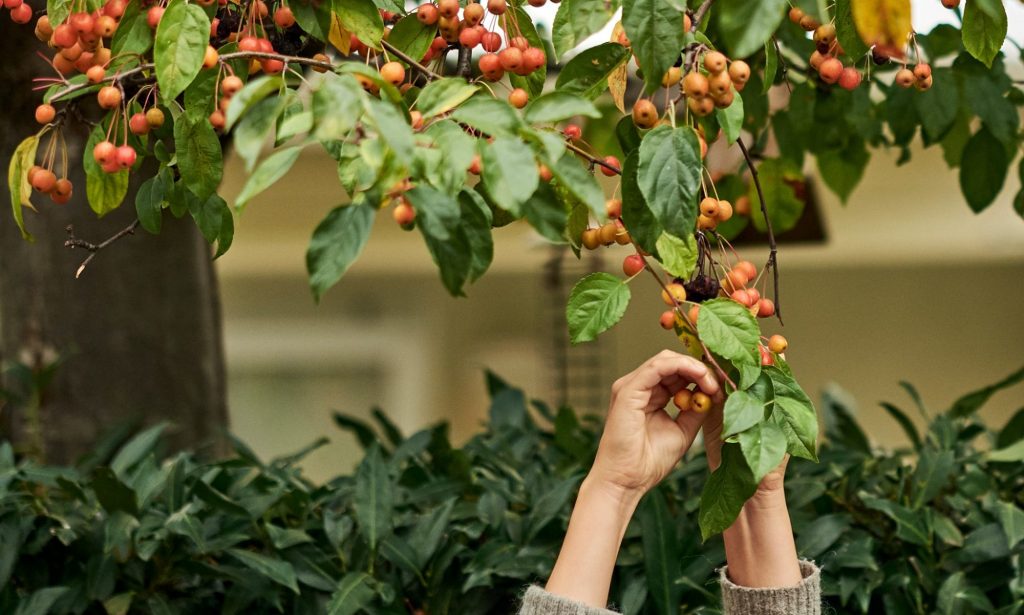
[719,561,821,615]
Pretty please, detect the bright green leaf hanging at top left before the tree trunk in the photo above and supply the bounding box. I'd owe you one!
[153,0,210,103]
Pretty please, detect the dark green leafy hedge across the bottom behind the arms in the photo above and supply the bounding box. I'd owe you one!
[0,369,1024,615]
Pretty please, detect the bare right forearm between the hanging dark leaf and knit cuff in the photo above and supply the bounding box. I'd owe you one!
[723,489,803,587]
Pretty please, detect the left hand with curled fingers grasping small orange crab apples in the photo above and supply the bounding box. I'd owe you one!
[591,350,723,497]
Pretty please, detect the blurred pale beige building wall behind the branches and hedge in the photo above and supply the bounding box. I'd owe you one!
[219,133,1024,478]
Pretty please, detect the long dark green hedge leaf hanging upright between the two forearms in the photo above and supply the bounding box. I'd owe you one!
[637,489,683,615]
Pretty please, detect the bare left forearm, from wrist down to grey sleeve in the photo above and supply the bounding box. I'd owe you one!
[545,477,640,608]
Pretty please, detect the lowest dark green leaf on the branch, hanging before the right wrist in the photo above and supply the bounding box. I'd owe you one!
[697,442,758,540]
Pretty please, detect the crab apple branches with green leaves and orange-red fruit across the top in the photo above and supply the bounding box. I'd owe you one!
[9,0,1024,536]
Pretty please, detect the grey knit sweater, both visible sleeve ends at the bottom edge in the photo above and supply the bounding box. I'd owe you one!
[519,561,821,615]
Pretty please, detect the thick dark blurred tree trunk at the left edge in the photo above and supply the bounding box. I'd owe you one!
[0,13,227,463]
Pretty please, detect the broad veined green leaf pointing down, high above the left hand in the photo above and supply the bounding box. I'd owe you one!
[637,126,701,237]
